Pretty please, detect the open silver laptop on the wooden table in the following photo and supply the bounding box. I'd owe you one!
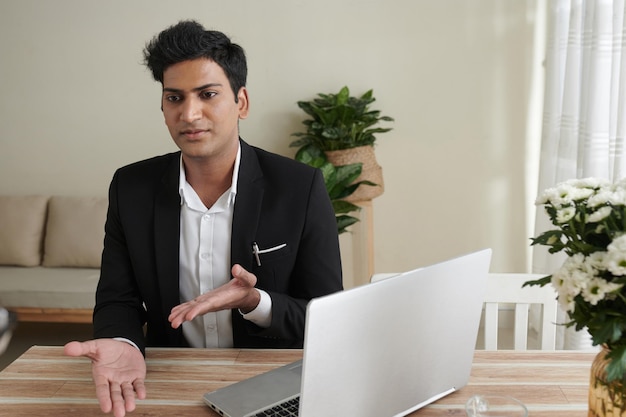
[204,249,491,417]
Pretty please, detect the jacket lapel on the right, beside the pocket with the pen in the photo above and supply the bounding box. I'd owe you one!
[231,140,265,271]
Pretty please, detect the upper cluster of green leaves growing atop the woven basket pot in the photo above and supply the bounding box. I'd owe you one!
[291,87,394,151]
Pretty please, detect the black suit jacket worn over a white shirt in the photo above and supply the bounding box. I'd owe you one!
[93,141,342,351]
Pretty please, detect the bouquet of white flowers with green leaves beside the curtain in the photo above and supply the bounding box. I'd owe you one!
[524,178,626,381]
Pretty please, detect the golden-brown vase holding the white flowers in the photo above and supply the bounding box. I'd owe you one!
[587,347,626,417]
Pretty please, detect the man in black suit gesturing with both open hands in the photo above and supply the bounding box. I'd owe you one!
[65,21,342,417]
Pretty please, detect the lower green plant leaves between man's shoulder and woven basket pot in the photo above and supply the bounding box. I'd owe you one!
[295,145,367,234]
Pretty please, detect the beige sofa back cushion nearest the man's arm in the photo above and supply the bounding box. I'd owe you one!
[43,196,107,268]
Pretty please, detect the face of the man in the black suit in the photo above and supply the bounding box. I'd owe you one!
[162,58,248,159]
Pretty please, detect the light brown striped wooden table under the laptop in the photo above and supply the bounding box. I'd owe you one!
[0,346,595,417]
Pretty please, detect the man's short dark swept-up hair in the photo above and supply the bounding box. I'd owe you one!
[143,20,248,101]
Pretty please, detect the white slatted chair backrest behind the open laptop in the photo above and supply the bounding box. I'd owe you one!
[370,273,557,350]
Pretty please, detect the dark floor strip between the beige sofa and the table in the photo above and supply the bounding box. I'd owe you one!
[0,323,92,370]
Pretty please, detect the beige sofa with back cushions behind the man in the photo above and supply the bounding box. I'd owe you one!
[0,196,107,323]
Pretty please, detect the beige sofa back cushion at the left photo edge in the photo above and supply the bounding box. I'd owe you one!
[0,196,48,266]
